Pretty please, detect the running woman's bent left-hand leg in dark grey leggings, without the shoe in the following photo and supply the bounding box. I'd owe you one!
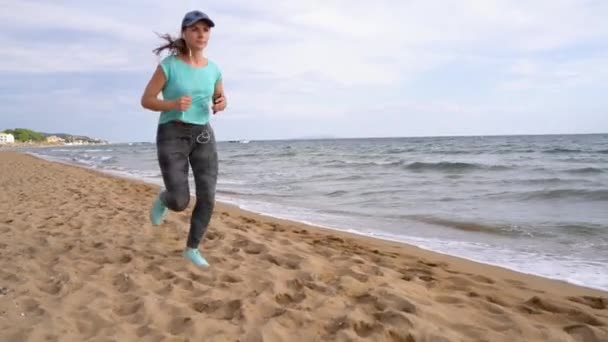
[156,122,192,211]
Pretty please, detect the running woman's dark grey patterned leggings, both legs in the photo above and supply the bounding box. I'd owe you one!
[156,121,218,248]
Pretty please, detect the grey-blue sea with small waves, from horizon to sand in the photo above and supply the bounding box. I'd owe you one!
[23,134,608,290]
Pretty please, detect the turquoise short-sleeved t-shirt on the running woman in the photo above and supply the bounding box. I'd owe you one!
[159,55,222,125]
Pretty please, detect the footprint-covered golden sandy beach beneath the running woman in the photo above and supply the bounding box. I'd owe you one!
[0,152,608,342]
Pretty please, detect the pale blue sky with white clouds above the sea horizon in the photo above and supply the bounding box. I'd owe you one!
[0,0,608,142]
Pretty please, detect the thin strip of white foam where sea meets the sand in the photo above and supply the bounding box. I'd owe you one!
[23,151,608,293]
